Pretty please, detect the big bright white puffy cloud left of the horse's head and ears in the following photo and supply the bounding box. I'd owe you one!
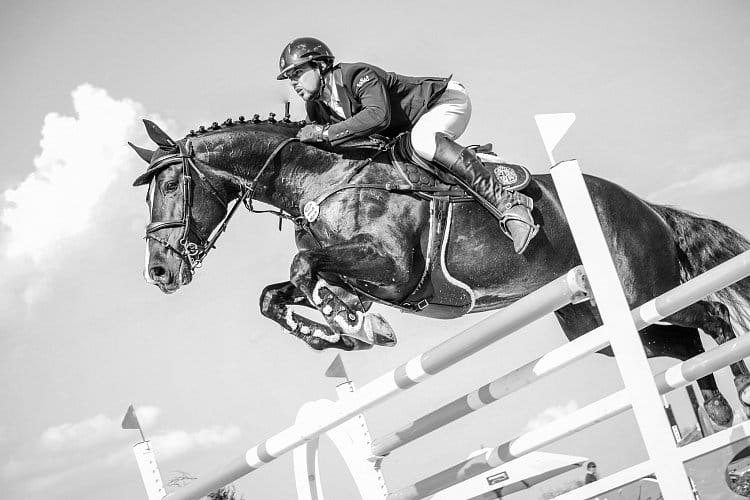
[0,84,150,262]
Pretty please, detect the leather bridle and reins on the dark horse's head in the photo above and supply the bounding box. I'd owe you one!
[144,137,299,274]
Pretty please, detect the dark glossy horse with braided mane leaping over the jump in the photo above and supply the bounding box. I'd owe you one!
[130,115,750,426]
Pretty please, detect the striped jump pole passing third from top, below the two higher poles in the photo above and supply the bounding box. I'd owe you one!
[386,328,750,500]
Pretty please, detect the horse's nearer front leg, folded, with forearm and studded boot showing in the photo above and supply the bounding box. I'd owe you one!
[290,235,408,346]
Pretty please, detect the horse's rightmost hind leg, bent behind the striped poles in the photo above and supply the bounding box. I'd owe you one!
[665,300,750,422]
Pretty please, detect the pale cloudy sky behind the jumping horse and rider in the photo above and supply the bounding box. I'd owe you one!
[0,0,750,500]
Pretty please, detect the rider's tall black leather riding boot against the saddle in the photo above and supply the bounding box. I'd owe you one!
[434,133,539,254]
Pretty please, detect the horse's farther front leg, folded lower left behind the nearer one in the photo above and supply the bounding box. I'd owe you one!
[260,281,371,351]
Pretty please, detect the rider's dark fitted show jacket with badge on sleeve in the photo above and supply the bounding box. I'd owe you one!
[306,62,450,145]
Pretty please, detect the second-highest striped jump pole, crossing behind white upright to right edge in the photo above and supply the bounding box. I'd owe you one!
[372,250,750,457]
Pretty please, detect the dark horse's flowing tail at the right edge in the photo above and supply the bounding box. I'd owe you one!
[649,204,750,332]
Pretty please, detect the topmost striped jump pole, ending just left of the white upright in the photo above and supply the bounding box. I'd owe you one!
[164,266,587,500]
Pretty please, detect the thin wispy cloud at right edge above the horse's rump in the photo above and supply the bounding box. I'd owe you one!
[648,161,750,203]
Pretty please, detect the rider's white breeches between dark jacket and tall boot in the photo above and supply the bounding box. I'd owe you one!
[411,80,471,161]
